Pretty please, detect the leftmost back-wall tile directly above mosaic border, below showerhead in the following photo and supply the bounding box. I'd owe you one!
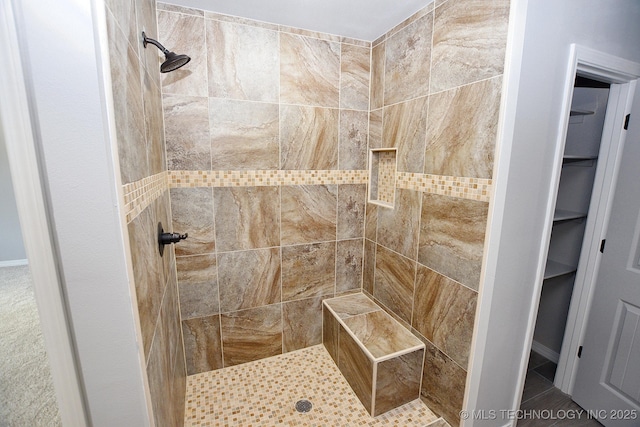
[162,94,211,170]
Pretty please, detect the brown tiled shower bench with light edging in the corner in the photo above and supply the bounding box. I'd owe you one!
[322,294,425,417]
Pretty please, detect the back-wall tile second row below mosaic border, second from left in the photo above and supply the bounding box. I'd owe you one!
[218,248,281,313]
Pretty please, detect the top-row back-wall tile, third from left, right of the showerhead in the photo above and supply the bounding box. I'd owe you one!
[280,33,340,108]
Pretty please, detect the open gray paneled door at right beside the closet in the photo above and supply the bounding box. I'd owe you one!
[572,91,640,427]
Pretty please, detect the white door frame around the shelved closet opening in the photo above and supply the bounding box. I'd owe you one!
[540,44,640,394]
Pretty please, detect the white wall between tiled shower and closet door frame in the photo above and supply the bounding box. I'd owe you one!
[465,0,640,426]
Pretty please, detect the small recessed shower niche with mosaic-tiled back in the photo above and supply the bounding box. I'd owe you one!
[368,148,398,209]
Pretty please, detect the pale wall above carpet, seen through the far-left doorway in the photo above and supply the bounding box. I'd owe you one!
[0,124,27,265]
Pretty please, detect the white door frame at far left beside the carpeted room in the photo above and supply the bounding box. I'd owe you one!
[0,0,88,427]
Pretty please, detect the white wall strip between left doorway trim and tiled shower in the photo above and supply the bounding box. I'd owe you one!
[14,0,150,426]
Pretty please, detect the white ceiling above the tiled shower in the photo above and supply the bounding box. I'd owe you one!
[165,0,433,41]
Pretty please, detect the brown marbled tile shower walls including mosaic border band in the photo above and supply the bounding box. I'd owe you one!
[106,0,509,425]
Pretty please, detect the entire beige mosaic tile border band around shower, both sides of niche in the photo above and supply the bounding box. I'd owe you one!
[122,170,492,223]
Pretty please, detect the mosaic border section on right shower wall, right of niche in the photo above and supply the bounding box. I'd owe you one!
[396,172,492,202]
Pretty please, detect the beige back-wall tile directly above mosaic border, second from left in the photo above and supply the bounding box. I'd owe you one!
[209,98,280,170]
